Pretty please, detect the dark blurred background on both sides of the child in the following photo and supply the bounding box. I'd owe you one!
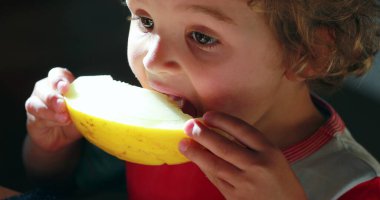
[0,0,380,192]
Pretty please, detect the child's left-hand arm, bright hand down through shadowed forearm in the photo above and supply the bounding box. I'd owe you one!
[23,68,81,184]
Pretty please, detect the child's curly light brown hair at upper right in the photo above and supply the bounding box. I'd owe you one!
[248,0,380,89]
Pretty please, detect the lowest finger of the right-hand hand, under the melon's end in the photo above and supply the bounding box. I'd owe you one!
[179,138,241,185]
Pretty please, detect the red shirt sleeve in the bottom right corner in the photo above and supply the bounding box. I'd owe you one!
[339,177,380,200]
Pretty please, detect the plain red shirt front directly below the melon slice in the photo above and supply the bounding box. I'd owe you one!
[126,163,224,200]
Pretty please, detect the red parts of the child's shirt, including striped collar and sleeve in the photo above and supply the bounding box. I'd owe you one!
[126,99,380,200]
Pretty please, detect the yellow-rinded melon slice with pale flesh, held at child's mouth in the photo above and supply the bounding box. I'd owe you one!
[65,75,192,165]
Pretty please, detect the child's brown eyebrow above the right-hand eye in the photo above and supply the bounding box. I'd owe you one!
[181,5,236,25]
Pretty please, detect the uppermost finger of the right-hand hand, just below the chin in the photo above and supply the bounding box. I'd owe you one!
[203,111,272,151]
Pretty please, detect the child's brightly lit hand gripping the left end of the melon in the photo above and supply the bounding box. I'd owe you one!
[25,68,81,151]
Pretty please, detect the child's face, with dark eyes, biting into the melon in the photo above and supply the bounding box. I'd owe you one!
[127,0,288,124]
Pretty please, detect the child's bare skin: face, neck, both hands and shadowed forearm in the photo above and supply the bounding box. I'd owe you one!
[24,0,323,199]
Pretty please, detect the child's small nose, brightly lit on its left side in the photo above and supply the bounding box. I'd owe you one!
[143,36,180,73]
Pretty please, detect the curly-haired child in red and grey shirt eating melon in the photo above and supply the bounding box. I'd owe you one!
[24,0,380,200]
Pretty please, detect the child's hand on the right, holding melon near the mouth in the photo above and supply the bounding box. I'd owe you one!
[180,112,306,200]
